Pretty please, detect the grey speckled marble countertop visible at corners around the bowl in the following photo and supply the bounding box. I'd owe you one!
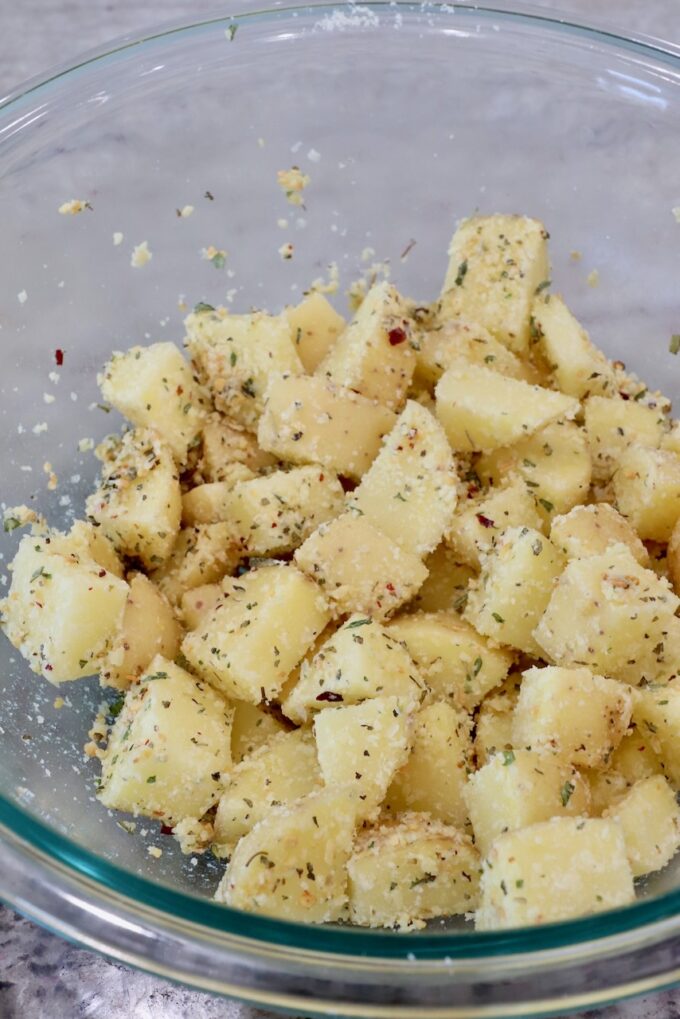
[0,0,680,1019]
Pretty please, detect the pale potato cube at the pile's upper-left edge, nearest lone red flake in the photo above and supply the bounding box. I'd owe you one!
[97,343,207,464]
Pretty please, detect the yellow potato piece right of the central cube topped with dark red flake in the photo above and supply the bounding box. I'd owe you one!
[386,612,514,711]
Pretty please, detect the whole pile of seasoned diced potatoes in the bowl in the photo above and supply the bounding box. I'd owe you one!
[3,215,680,929]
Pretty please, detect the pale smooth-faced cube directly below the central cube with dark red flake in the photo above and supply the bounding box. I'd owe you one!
[314,697,414,817]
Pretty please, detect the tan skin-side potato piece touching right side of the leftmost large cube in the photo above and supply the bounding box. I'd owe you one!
[99,574,181,690]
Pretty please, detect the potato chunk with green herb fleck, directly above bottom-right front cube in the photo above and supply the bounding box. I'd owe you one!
[464,750,590,856]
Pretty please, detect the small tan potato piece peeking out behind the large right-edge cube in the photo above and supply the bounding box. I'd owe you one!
[551,502,649,566]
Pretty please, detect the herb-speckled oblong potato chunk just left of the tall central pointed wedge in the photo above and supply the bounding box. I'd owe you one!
[224,467,345,555]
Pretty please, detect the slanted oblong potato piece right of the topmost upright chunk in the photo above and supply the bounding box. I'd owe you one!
[531,293,617,399]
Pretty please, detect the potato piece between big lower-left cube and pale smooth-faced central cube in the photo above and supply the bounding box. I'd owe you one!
[212,729,322,856]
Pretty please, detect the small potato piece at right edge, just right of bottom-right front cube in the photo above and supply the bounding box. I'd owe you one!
[605,774,680,877]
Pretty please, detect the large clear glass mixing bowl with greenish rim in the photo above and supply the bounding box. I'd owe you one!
[0,0,680,1019]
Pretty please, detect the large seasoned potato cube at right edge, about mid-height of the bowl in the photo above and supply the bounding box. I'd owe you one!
[534,544,680,686]
